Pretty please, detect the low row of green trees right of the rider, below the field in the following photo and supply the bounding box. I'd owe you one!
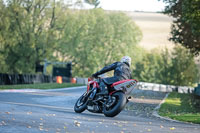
[133,46,198,86]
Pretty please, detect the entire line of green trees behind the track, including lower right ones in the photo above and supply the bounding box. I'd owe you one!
[0,0,199,85]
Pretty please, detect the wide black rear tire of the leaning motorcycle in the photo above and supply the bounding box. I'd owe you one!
[103,92,126,117]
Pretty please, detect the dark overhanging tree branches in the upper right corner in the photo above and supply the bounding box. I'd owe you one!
[163,0,200,54]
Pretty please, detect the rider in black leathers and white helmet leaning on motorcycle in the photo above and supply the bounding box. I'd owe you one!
[92,56,132,95]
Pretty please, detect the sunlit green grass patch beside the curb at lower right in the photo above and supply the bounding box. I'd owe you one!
[159,92,200,124]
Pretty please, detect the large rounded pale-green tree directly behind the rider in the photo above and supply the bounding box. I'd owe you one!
[57,9,141,76]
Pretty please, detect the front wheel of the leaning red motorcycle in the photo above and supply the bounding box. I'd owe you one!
[74,93,88,113]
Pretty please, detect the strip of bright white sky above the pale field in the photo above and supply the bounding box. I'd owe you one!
[100,0,165,12]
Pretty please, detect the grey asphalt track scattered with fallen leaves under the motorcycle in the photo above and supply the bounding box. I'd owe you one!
[0,87,200,133]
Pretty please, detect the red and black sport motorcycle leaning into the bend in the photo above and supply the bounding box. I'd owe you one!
[74,77,138,117]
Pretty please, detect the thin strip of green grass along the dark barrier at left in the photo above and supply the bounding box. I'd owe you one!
[0,83,83,90]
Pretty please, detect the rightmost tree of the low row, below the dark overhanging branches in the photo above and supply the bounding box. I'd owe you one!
[170,46,198,86]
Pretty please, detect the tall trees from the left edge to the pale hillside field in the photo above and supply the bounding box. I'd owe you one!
[0,0,142,77]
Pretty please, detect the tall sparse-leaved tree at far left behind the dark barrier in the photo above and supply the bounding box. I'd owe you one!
[0,0,62,73]
